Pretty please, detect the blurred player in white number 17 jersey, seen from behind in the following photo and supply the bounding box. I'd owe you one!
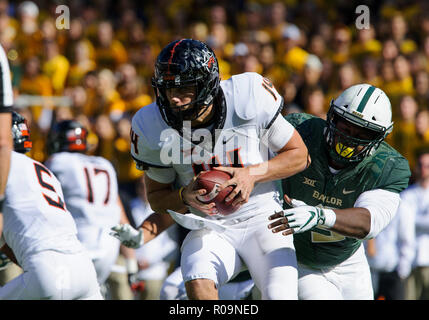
[46,120,138,286]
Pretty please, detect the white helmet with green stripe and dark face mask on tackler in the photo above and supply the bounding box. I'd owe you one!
[325,84,393,167]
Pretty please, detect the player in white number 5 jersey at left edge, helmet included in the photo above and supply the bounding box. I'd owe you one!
[0,112,102,300]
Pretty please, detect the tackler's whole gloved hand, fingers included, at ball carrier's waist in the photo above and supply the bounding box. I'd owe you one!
[268,195,335,236]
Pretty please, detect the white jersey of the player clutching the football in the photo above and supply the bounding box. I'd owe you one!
[131,72,294,218]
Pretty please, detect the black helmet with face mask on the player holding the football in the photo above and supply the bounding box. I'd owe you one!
[152,39,220,131]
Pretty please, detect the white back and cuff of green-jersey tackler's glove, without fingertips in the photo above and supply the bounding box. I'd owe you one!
[283,205,336,233]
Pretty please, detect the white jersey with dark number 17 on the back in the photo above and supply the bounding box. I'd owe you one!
[46,152,121,232]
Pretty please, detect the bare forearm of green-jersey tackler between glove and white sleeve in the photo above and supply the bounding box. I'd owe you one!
[330,208,371,239]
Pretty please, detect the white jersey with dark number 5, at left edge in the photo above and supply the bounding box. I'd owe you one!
[3,151,82,263]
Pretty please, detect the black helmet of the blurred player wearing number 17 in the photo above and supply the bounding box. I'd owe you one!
[47,120,88,154]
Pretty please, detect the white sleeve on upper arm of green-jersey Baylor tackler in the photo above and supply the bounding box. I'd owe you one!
[354,189,400,240]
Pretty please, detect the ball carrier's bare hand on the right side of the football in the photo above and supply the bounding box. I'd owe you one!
[213,167,256,210]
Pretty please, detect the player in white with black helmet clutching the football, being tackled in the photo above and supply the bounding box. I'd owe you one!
[114,39,309,299]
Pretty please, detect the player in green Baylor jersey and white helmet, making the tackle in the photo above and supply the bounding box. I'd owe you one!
[268,84,411,299]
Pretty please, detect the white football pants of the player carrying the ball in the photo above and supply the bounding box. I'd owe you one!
[181,210,298,300]
